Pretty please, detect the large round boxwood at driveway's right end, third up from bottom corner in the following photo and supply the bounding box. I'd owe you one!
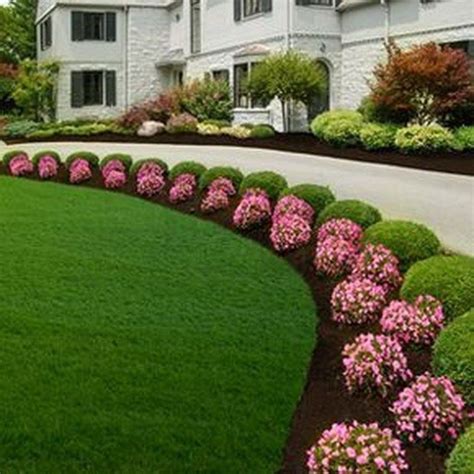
[400,255,474,319]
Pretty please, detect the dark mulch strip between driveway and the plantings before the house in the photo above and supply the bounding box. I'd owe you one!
[5,133,474,175]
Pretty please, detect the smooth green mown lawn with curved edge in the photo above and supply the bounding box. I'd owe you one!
[0,177,315,474]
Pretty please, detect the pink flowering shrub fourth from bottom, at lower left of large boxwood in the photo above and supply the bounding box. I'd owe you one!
[380,295,444,345]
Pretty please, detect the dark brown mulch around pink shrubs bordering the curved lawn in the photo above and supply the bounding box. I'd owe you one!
[0,165,449,474]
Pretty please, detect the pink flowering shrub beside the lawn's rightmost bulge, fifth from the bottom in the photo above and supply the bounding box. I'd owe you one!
[331,278,387,324]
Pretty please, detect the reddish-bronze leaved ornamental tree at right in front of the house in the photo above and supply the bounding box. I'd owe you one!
[370,42,474,125]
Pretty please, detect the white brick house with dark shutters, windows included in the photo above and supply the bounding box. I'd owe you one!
[37,0,474,128]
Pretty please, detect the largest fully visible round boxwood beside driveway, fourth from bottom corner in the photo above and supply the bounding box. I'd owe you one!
[364,220,441,271]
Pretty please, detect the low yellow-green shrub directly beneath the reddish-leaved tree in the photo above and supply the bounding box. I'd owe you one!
[395,124,457,153]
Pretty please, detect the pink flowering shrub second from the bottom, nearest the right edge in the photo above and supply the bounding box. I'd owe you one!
[390,372,465,443]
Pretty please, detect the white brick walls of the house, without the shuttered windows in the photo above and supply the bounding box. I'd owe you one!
[38,0,474,130]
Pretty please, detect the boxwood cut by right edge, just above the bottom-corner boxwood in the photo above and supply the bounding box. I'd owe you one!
[433,308,474,403]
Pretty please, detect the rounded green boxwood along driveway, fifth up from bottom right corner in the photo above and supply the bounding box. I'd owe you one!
[317,199,382,229]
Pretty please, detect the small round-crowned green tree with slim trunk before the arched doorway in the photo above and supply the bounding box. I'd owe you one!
[246,51,327,131]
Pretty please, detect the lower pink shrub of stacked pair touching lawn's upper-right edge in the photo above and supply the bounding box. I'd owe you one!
[270,214,311,252]
